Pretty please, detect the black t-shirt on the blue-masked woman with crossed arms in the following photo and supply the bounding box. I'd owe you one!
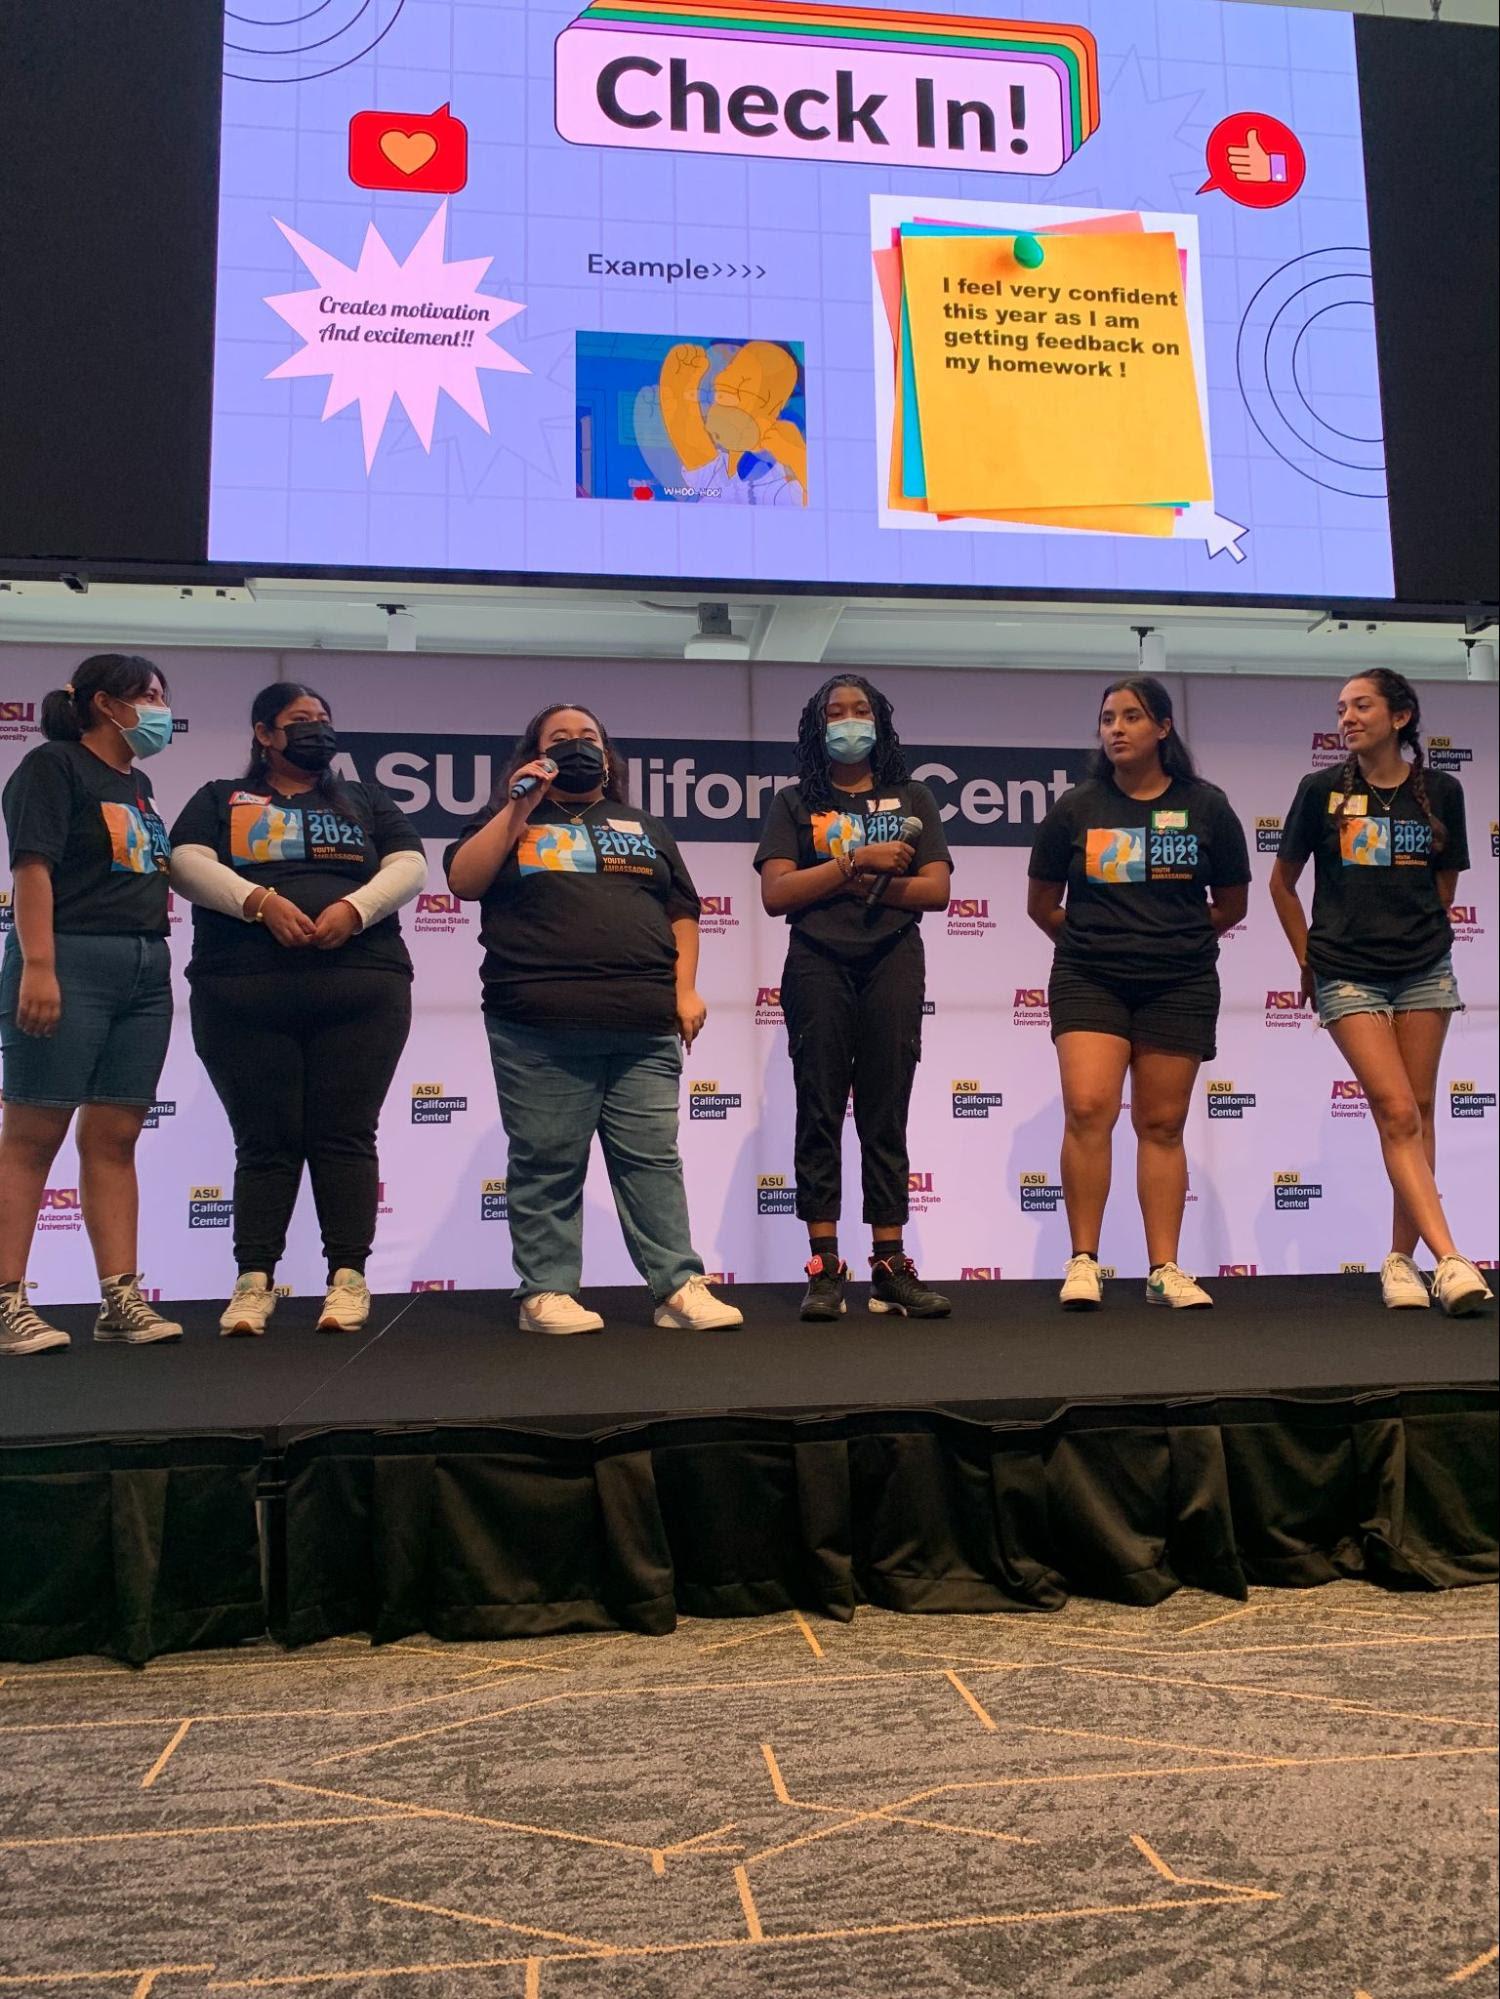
[756,782,952,956]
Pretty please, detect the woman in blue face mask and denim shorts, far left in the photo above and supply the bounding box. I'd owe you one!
[0,652,182,1353]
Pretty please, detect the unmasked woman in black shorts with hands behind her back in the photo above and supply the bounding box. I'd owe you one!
[1026,676,1250,1311]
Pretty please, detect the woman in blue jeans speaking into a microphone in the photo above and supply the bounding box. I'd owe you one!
[446,702,742,1333]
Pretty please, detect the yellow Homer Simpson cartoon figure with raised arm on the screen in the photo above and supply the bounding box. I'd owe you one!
[658,340,808,506]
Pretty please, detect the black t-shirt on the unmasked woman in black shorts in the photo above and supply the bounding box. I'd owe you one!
[1028,778,1250,984]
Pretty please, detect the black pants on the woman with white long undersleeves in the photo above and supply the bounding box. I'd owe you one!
[192,966,412,1273]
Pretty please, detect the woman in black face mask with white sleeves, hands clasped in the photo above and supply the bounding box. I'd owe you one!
[172,682,426,1333]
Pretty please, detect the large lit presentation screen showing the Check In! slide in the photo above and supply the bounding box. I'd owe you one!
[208,0,1394,600]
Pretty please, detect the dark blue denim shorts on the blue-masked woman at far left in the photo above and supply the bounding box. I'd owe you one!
[0,930,172,1109]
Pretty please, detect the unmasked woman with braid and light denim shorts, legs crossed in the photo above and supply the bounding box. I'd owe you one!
[1270,668,1490,1317]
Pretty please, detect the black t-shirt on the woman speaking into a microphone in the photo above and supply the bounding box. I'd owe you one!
[444,798,698,1035]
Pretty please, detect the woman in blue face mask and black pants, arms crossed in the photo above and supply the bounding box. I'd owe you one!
[756,674,952,1319]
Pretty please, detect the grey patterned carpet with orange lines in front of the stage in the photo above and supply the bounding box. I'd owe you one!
[0,1585,1500,1999]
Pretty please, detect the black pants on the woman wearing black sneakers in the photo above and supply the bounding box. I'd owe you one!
[782,924,926,1227]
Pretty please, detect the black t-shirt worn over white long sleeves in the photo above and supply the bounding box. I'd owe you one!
[172,778,422,978]
